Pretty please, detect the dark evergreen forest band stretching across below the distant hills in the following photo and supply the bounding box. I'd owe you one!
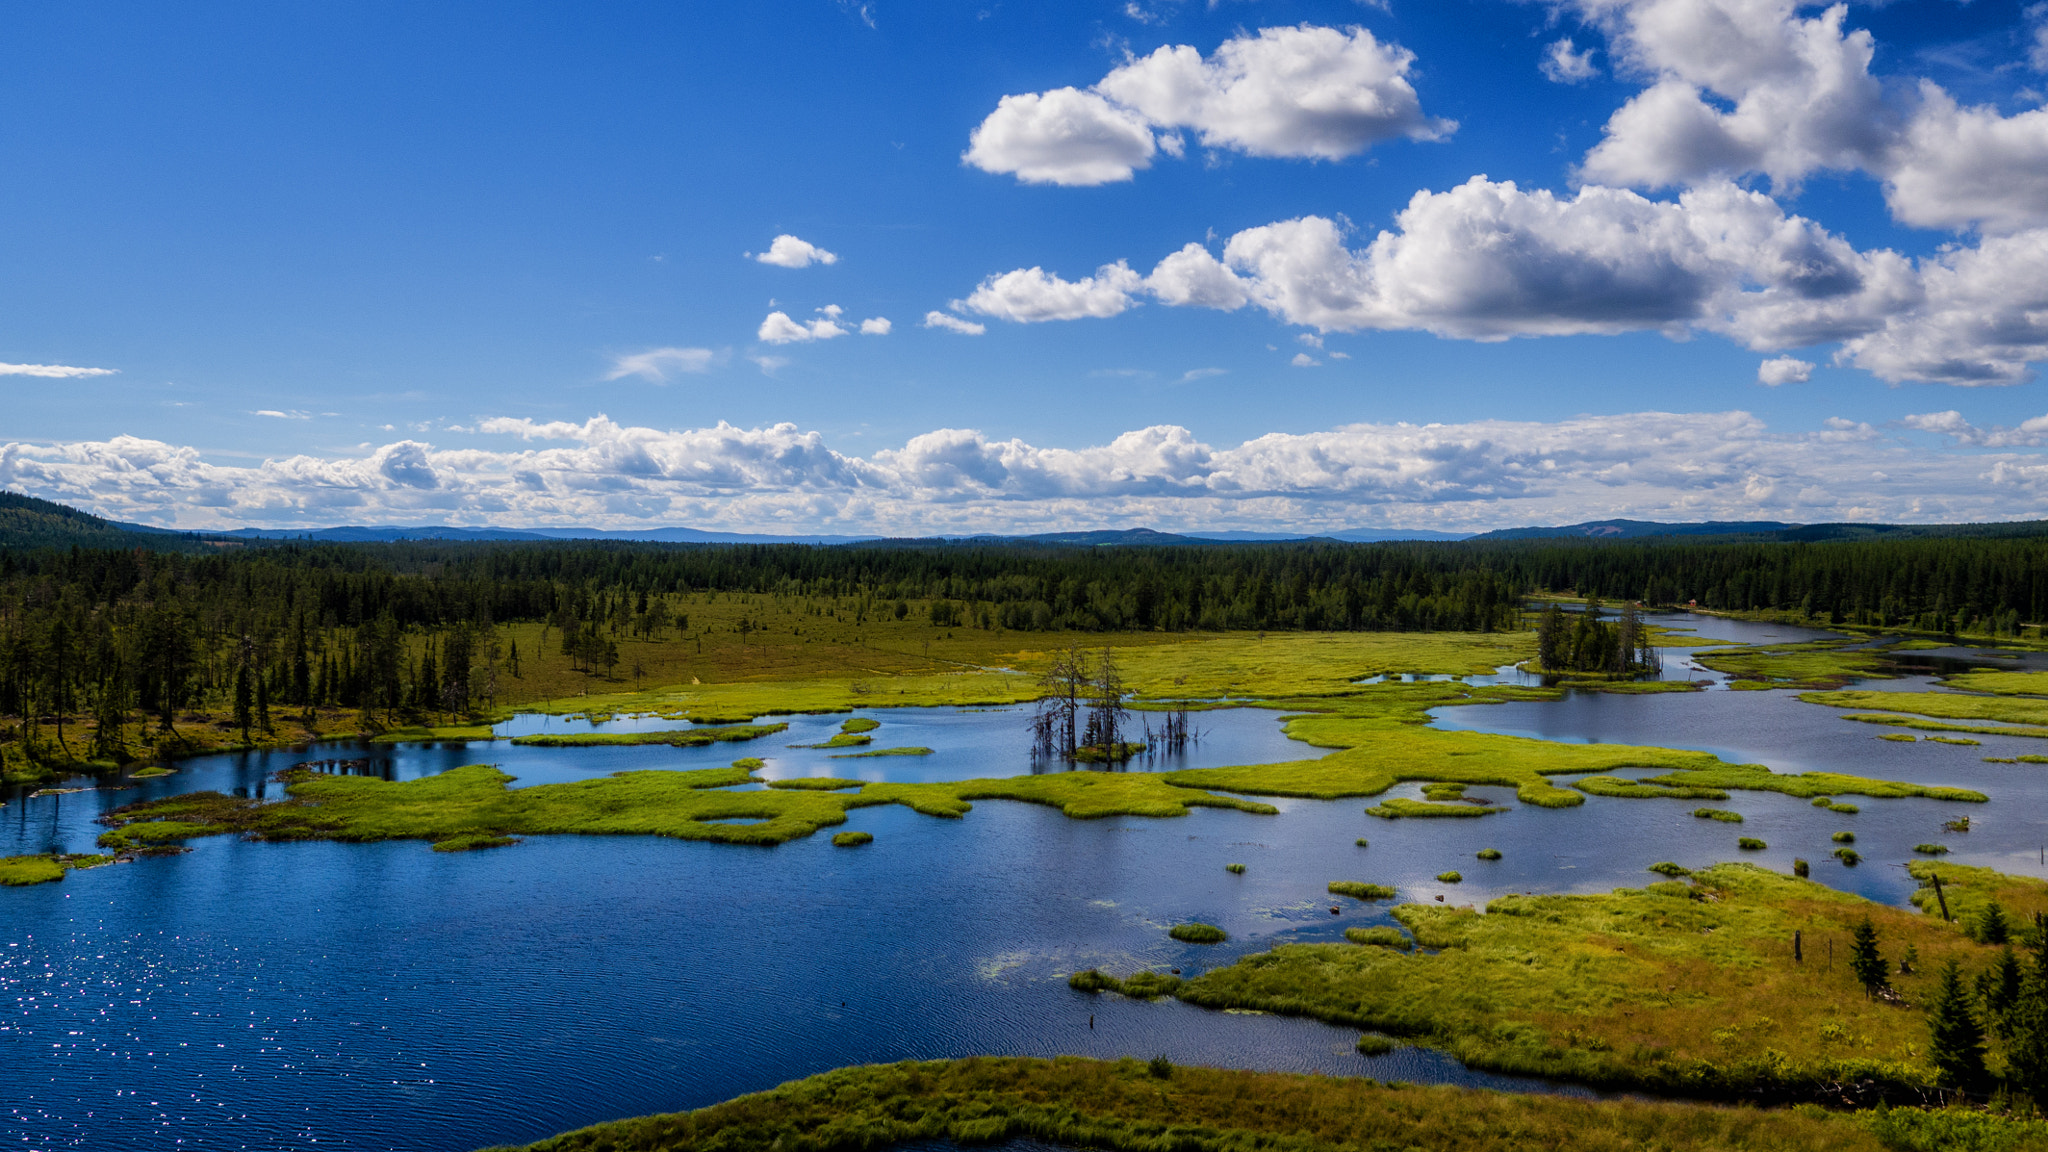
[0,500,2048,756]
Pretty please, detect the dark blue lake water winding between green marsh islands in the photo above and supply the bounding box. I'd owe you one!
[0,621,2048,1150]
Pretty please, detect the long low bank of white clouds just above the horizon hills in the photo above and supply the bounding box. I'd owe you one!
[0,410,2048,535]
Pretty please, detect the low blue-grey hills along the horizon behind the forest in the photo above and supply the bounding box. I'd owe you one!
[0,492,2048,551]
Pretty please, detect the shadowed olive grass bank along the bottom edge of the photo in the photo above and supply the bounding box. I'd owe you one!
[494,1058,2048,1152]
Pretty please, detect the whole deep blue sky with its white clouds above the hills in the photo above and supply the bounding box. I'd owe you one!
[0,0,2048,531]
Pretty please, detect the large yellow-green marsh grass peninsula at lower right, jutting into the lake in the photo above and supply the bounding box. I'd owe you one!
[1155,861,2048,1099]
